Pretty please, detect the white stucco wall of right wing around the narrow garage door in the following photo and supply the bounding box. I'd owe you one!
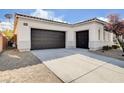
[72,22,113,50]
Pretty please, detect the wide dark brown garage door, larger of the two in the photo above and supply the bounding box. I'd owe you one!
[31,28,65,49]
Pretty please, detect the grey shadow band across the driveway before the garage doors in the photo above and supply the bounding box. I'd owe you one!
[32,48,124,68]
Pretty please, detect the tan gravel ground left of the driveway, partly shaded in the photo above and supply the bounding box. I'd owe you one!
[0,50,62,83]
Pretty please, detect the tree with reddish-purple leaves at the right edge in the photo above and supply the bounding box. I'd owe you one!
[105,14,124,55]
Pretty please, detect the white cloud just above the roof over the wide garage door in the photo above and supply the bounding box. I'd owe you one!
[31,9,67,23]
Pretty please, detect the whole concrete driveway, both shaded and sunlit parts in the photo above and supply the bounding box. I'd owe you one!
[32,49,124,83]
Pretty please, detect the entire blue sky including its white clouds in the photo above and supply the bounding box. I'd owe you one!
[0,9,124,29]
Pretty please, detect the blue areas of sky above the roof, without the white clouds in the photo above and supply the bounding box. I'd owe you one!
[0,9,124,23]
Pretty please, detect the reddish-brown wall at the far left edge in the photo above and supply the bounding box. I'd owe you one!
[0,33,8,52]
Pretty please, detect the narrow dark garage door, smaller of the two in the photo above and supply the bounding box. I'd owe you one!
[76,30,89,48]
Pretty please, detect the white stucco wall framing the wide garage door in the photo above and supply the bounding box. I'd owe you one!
[17,18,75,51]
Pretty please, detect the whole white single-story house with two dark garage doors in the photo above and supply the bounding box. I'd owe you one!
[14,14,113,51]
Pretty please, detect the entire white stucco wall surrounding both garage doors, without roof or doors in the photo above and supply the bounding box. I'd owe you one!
[16,18,112,51]
